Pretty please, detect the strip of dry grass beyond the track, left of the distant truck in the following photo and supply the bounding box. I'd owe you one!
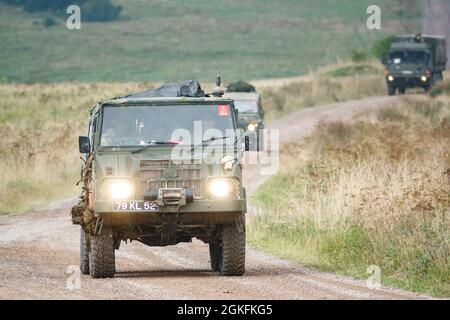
[255,61,386,122]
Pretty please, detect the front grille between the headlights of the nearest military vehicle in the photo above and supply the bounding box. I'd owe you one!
[139,160,202,198]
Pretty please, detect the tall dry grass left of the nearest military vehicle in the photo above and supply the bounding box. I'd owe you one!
[0,83,148,214]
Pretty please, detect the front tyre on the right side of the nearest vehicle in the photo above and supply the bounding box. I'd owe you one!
[219,213,245,276]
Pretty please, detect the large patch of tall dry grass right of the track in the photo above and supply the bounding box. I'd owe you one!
[249,96,450,296]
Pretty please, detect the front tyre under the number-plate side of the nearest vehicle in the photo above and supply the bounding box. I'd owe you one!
[89,227,116,278]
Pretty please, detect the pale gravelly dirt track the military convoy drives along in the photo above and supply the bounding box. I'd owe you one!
[0,97,430,299]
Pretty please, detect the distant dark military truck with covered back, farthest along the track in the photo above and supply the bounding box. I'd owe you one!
[382,34,447,95]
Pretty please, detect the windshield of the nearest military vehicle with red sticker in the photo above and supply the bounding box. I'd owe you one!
[100,104,235,147]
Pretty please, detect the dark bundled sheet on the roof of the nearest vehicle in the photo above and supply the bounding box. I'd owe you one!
[125,80,205,98]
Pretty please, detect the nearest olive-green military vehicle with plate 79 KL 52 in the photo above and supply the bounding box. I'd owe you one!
[71,78,249,278]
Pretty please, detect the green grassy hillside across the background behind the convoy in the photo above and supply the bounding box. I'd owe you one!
[0,0,422,83]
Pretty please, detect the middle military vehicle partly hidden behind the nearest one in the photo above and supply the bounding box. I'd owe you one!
[224,81,264,151]
